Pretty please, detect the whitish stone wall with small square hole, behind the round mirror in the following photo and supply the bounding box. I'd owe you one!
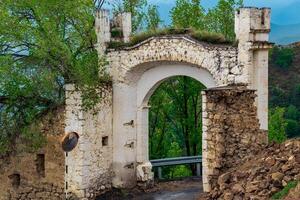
[65,84,112,199]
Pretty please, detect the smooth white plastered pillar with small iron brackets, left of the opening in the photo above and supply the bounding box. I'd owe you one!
[113,83,137,188]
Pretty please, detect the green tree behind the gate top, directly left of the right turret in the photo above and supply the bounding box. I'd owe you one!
[205,0,243,41]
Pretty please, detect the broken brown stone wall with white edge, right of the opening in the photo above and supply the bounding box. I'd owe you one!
[202,86,267,191]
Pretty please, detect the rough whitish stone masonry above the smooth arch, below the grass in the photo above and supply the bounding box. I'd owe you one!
[107,35,241,85]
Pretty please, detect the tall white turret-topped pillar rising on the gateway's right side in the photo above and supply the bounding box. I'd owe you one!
[235,7,272,130]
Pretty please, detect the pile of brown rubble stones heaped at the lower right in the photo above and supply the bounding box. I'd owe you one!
[205,139,300,200]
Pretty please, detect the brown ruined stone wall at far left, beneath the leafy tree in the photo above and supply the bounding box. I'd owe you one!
[0,107,65,200]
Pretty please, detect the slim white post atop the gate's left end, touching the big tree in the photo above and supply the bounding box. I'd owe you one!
[95,9,111,55]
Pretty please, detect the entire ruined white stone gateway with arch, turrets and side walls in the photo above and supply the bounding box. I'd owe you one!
[65,8,271,198]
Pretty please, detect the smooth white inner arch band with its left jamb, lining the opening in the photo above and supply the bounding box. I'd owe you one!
[136,63,216,163]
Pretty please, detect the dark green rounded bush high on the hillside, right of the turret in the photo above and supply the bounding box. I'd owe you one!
[271,46,295,69]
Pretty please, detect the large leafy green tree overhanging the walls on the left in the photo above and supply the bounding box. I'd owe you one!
[0,0,109,152]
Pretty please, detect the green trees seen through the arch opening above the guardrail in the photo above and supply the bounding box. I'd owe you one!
[149,76,205,176]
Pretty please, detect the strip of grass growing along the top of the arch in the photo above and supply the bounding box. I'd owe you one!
[108,28,233,49]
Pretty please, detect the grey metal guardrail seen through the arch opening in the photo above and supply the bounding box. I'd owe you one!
[150,156,202,179]
